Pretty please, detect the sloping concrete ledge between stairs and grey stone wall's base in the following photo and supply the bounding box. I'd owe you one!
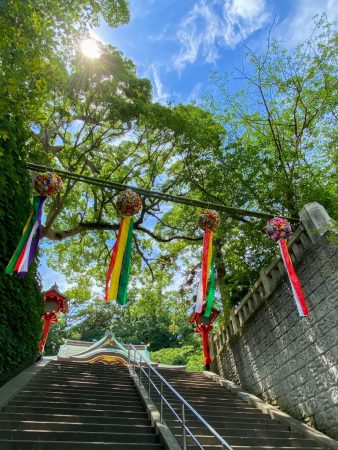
[203,371,338,450]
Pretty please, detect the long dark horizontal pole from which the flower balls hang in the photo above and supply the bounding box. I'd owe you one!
[26,163,299,223]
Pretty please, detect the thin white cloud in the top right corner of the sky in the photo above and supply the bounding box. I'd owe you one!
[278,0,338,47]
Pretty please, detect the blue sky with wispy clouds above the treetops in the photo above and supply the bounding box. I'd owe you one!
[95,0,338,103]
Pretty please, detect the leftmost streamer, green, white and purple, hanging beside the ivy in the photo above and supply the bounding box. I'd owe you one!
[5,195,47,278]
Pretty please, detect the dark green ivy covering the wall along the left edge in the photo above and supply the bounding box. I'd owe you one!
[0,118,42,385]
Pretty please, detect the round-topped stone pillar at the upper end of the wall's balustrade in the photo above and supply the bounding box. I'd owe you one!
[299,202,331,244]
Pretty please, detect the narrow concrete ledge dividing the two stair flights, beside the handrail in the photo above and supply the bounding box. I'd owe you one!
[129,366,182,450]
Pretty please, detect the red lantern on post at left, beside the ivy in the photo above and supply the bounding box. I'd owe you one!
[39,283,68,353]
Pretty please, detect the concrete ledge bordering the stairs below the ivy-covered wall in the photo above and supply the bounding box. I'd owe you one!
[0,358,51,411]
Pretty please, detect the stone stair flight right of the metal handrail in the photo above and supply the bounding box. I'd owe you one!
[157,369,326,450]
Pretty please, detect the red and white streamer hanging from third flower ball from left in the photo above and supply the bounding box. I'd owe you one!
[195,231,215,313]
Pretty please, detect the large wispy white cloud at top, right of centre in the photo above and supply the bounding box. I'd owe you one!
[173,0,270,71]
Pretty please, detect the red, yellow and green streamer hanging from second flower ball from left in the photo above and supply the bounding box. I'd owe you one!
[105,216,134,305]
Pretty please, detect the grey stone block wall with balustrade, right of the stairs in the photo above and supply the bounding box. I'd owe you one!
[212,204,338,439]
